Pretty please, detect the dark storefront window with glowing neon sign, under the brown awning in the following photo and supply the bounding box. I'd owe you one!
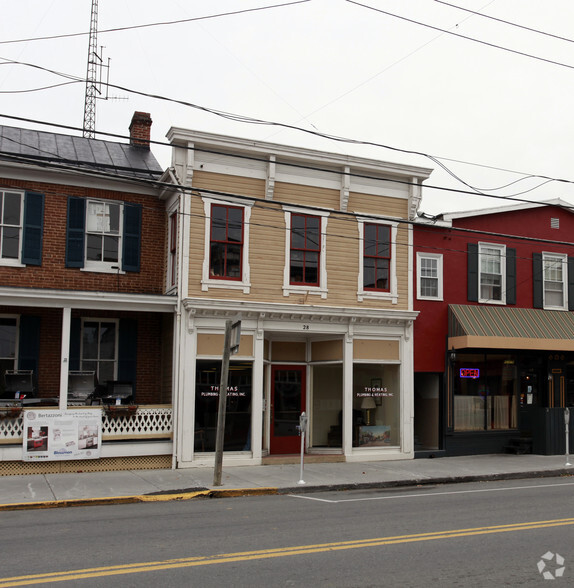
[451,353,518,431]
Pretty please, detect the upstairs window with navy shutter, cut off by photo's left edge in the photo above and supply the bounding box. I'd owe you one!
[0,189,44,265]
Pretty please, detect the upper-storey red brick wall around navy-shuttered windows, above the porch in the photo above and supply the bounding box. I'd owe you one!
[0,178,167,294]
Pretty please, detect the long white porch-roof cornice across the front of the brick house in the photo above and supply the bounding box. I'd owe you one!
[0,287,177,312]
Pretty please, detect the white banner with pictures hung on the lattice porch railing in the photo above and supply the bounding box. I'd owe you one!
[22,409,102,461]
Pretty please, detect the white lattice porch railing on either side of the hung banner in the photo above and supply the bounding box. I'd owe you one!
[0,404,173,444]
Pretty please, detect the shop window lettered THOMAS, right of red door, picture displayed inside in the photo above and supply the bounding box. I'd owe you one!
[353,364,400,448]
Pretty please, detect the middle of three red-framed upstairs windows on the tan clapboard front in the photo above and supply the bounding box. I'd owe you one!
[289,214,321,286]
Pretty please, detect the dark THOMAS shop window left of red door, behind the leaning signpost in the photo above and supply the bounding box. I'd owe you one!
[195,361,253,452]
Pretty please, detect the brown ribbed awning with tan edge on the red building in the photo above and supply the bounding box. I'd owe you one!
[448,304,574,351]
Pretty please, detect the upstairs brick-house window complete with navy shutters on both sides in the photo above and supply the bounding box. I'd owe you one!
[66,197,142,272]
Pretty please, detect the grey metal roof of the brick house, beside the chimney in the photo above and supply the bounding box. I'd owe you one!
[0,125,163,179]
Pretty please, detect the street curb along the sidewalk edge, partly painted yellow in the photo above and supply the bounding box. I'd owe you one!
[0,468,574,512]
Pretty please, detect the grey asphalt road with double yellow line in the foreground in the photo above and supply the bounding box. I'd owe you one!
[0,477,574,588]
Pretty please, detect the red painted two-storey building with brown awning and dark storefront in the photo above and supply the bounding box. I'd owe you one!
[413,200,574,455]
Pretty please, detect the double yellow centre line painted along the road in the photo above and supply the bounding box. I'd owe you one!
[0,518,574,588]
